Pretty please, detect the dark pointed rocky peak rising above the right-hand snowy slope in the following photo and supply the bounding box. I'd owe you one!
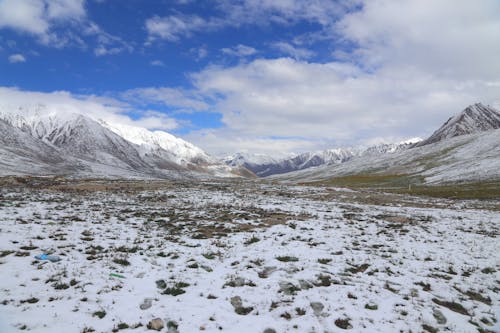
[415,103,500,147]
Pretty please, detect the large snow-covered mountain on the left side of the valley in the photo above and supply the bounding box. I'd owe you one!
[0,104,246,178]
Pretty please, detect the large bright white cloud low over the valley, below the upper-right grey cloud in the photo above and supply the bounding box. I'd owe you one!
[186,58,500,151]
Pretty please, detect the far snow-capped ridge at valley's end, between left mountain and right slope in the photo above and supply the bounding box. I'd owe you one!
[223,138,420,177]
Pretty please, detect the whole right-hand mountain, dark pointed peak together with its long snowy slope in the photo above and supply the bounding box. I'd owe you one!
[271,104,500,187]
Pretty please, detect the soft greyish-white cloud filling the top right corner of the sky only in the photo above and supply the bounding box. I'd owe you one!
[335,0,500,80]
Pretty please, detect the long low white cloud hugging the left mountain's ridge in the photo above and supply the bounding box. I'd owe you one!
[0,87,179,130]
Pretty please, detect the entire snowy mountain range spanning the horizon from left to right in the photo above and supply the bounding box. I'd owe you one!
[0,103,500,182]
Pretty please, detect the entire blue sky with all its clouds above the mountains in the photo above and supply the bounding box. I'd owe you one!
[0,0,500,156]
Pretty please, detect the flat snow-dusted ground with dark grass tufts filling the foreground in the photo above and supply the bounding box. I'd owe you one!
[0,182,500,333]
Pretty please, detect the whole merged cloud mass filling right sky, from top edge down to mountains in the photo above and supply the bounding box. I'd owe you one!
[175,0,500,152]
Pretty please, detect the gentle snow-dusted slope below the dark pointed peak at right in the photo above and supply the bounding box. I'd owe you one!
[272,129,500,184]
